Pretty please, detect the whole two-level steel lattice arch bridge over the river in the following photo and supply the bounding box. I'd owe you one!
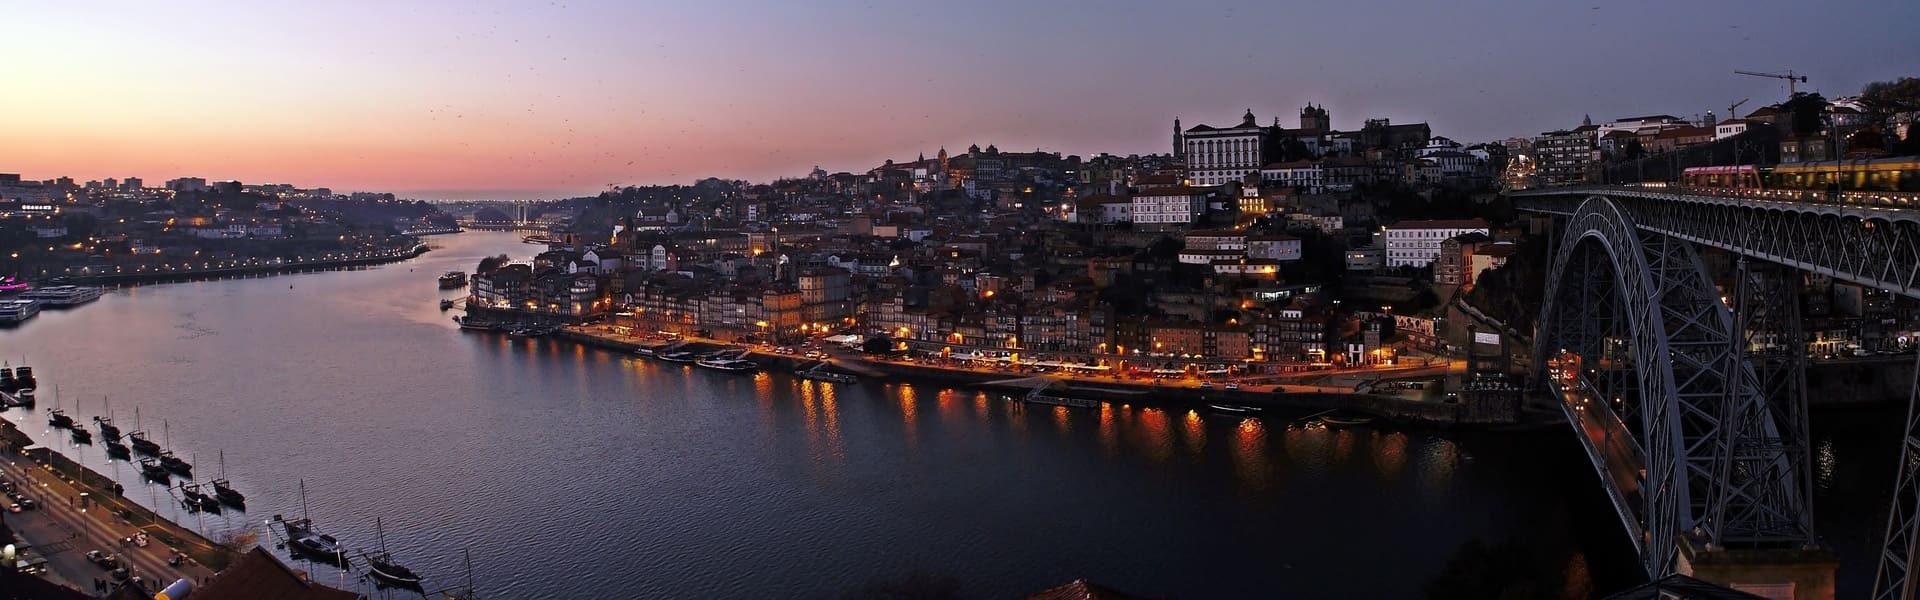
[1513,187,1920,598]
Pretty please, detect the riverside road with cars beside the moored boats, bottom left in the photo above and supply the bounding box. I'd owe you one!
[0,456,213,590]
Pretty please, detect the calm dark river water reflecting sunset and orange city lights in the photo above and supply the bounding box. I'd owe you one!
[15,233,1891,598]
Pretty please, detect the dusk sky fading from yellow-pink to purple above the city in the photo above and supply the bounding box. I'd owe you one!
[0,0,1920,200]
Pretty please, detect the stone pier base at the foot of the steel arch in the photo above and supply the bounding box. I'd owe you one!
[1676,537,1839,600]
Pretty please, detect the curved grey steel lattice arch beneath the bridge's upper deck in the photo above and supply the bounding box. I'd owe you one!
[1534,196,1812,577]
